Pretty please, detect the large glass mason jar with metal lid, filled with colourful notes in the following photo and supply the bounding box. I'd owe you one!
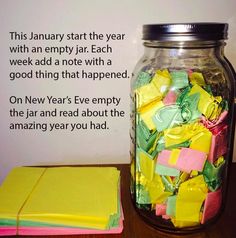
[130,23,235,233]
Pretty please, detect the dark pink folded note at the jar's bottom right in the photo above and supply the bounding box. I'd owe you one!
[201,189,222,224]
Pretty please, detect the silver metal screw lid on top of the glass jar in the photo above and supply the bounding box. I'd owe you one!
[143,22,228,41]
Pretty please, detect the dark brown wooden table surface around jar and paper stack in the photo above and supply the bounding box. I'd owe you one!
[5,163,236,238]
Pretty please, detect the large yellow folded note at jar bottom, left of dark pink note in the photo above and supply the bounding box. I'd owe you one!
[175,175,208,223]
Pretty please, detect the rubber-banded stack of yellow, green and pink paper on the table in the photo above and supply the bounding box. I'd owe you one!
[0,167,123,236]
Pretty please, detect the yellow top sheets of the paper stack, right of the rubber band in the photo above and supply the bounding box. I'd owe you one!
[20,167,119,229]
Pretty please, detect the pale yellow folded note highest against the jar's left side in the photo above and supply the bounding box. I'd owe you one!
[135,82,162,108]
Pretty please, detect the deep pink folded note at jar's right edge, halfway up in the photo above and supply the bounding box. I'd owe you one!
[208,125,228,163]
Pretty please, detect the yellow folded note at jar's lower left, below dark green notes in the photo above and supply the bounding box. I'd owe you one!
[138,149,156,181]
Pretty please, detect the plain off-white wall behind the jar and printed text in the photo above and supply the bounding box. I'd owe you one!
[0,0,236,181]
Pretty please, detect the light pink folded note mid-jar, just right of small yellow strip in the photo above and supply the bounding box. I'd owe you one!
[175,148,207,173]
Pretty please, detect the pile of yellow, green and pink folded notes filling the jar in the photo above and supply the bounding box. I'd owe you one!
[135,69,229,228]
